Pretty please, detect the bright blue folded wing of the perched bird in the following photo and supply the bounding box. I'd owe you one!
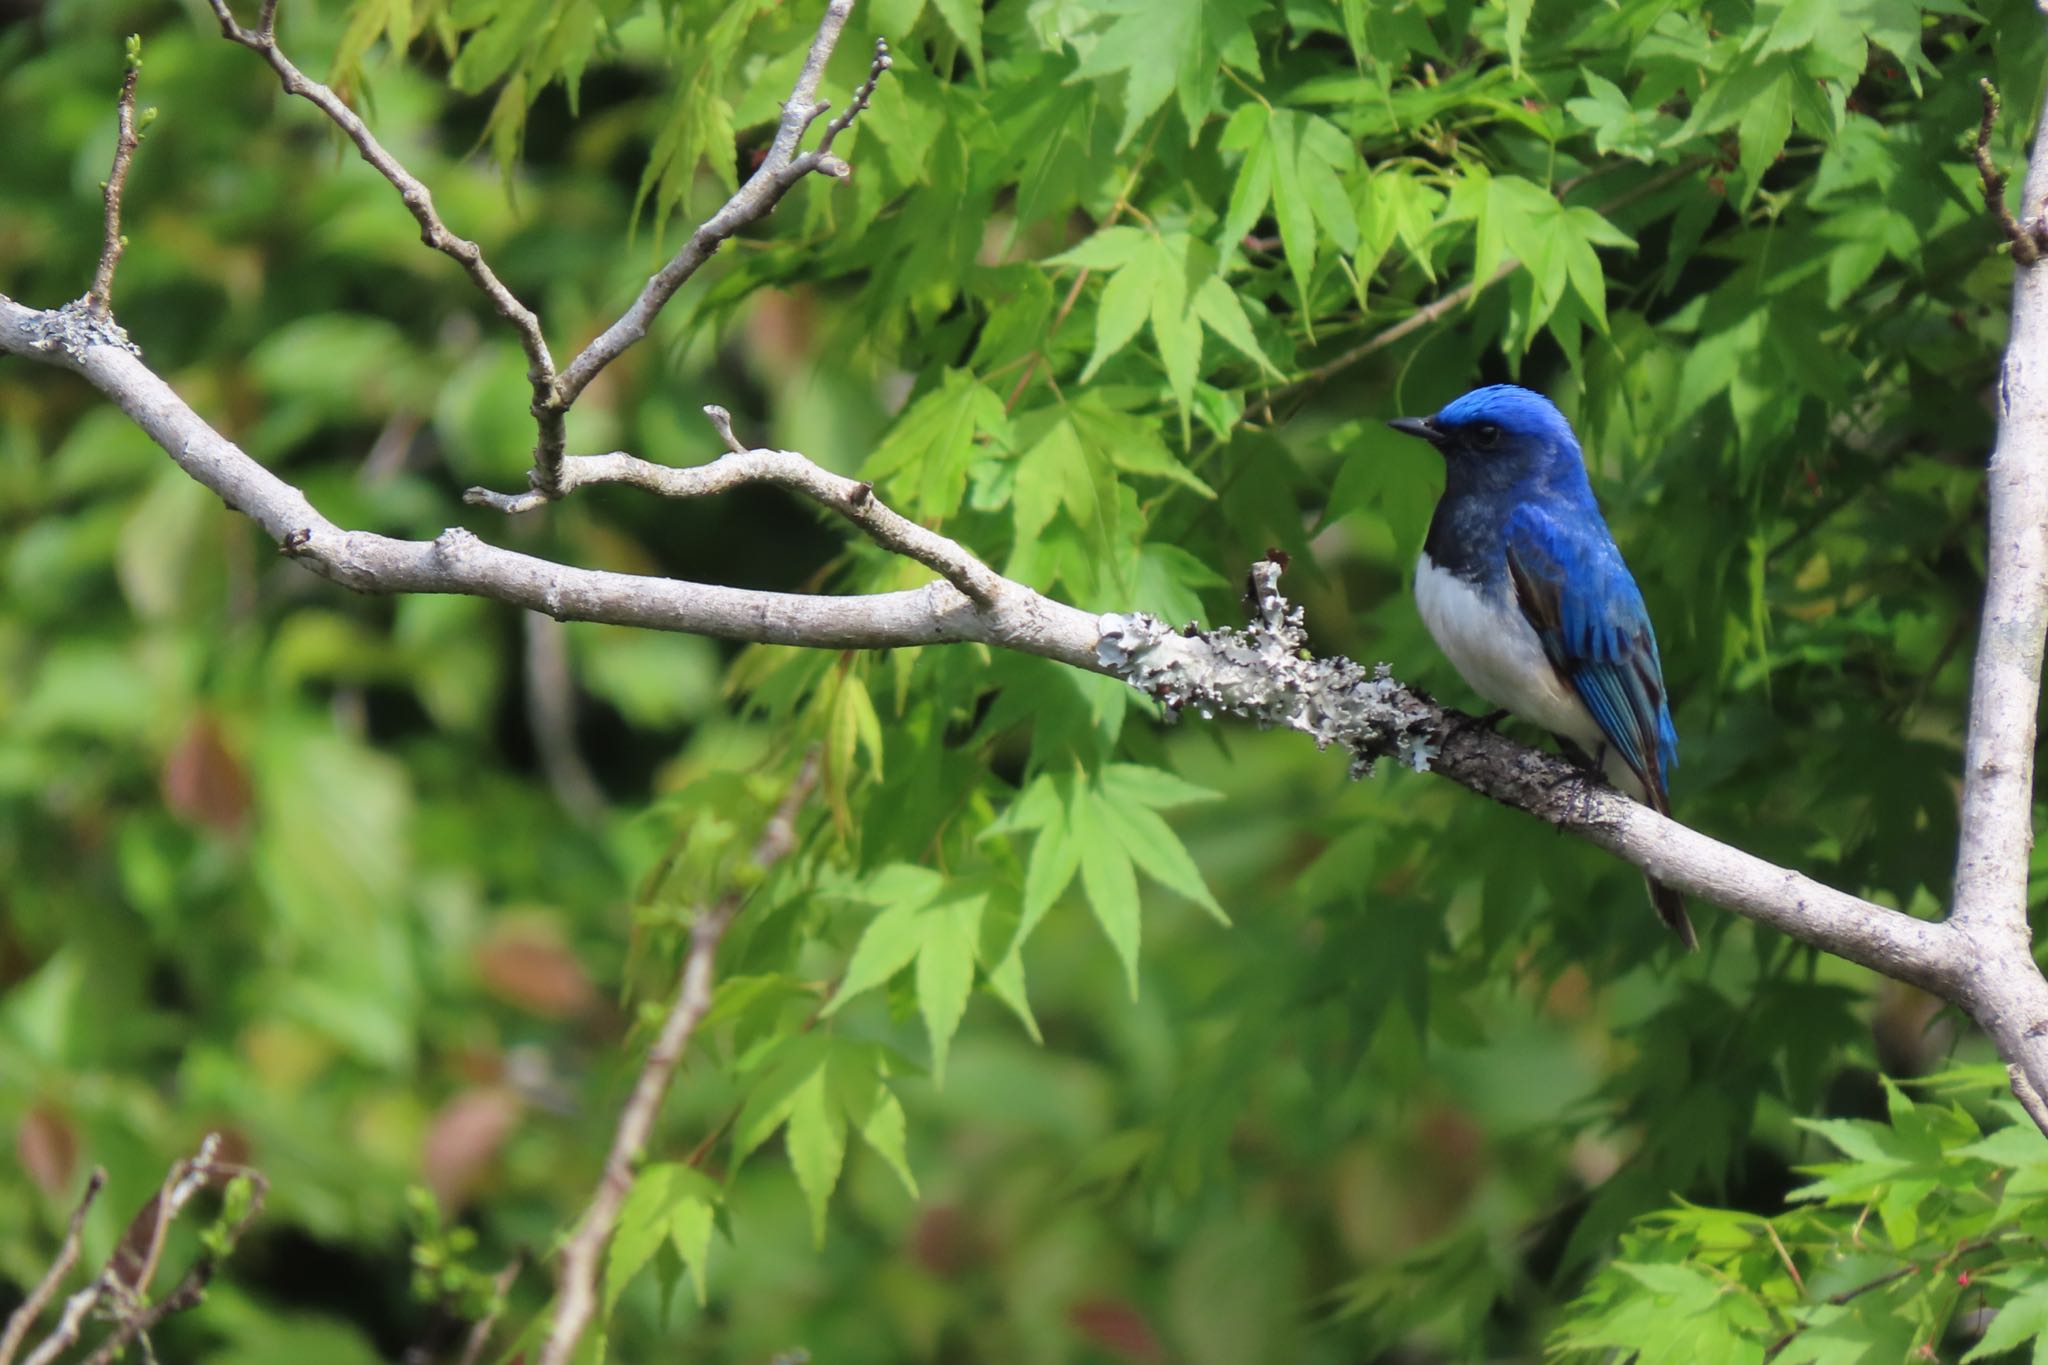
[1505,503,1677,806]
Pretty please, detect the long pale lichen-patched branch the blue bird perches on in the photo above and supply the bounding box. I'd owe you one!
[0,299,1982,1002]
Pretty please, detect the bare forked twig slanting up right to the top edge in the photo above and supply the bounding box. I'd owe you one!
[535,12,891,417]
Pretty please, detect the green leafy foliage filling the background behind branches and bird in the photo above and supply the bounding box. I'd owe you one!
[0,0,2048,1365]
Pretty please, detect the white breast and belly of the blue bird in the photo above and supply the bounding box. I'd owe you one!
[1415,555,1606,755]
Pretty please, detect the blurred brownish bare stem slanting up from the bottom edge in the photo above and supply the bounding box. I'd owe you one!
[541,753,819,1365]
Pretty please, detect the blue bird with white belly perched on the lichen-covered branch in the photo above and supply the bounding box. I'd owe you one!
[1389,385,1700,948]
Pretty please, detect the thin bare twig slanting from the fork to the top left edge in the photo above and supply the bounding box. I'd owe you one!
[207,0,567,469]
